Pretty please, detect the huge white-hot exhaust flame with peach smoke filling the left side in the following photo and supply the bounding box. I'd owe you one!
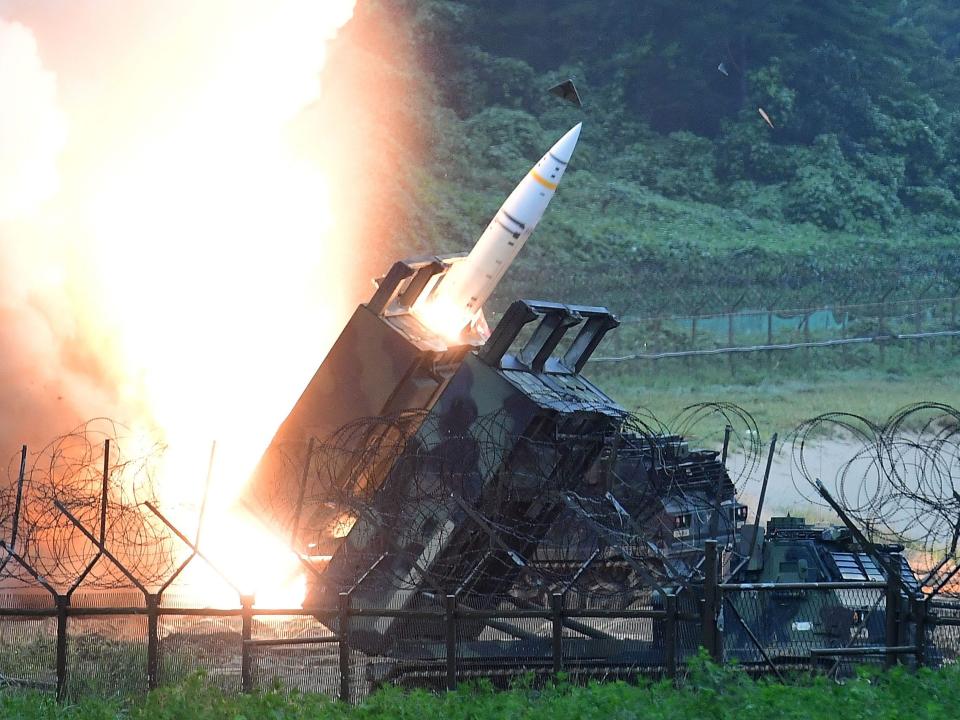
[0,0,354,604]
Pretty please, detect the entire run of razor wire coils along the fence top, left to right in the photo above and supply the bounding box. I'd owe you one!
[0,402,960,606]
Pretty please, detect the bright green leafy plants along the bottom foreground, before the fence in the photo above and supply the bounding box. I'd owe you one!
[0,661,960,720]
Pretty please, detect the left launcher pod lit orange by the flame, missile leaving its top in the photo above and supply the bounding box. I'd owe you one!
[244,255,483,540]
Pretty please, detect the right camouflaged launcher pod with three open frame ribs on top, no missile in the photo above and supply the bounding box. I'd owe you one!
[307,301,625,653]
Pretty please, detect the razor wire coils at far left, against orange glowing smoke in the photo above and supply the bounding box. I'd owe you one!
[0,418,175,592]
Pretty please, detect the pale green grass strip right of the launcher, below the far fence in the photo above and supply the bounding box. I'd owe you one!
[588,353,960,436]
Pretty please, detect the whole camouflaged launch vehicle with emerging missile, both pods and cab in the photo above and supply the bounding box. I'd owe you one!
[238,119,915,677]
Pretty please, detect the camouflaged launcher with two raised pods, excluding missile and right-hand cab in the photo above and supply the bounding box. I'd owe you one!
[247,257,745,676]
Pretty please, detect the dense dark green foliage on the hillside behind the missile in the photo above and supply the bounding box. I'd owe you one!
[371,0,960,312]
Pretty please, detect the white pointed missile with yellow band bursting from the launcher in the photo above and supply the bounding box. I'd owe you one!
[414,123,582,337]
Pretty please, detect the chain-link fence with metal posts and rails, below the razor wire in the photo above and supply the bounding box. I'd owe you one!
[0,543,960,701]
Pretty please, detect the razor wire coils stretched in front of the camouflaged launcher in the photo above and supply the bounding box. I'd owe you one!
[292,403,760,604]
